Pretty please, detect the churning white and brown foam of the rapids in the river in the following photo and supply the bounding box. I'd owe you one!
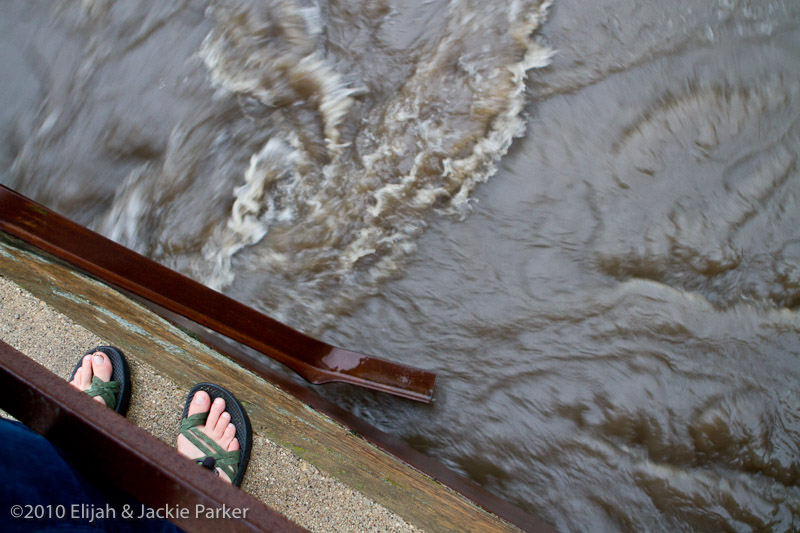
[111,0,550,329]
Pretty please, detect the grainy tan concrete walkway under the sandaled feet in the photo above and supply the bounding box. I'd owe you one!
[0,276,416,532]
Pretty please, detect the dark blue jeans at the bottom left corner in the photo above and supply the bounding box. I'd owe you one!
[0,419,180,533]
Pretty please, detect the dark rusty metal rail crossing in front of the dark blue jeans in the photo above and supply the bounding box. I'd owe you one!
[0,341,306,532]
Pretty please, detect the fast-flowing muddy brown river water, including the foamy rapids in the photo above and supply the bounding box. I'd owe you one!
[0,0,800,531]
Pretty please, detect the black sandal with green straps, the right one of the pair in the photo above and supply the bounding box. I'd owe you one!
[180,383,253,487]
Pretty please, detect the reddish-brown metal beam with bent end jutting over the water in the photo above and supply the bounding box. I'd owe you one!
[0,185,436,403]
